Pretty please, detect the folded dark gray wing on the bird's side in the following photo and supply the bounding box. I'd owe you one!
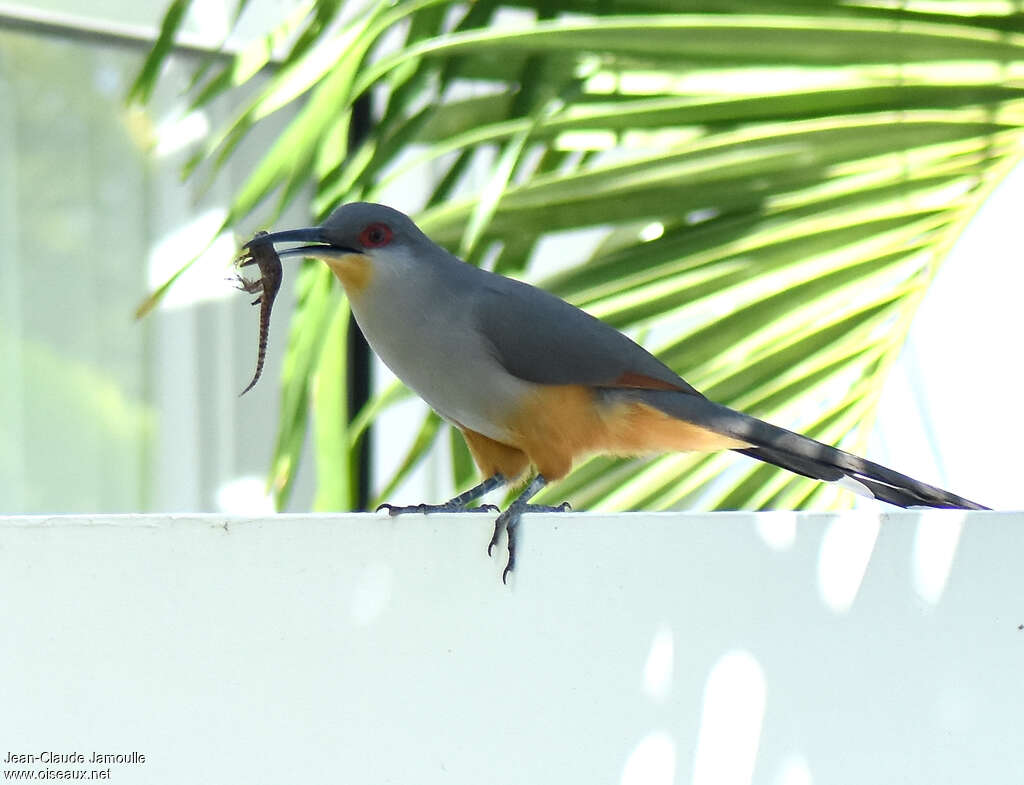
[474,273,700,395]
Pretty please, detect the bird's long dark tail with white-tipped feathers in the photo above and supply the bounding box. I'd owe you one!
[614,389,988,510]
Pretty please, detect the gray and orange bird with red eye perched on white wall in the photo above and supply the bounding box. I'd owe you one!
[247,203,987,580]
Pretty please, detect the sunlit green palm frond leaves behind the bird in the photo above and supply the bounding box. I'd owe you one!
[133,0,1024,509]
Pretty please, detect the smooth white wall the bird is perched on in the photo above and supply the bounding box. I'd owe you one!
[0,511,1024,785]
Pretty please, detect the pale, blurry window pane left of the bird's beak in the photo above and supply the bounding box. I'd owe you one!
[0,26,312,513]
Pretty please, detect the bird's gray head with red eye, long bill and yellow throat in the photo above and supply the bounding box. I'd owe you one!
[245,202,430,296]
